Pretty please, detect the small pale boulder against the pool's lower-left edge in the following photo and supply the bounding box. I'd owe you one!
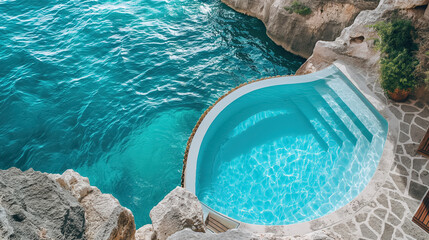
[149,187,205,240]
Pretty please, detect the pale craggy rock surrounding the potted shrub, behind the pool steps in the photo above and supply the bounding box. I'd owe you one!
[296,0,429,98]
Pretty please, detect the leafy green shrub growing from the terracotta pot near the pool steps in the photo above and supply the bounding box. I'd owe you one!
[372,19,419,92]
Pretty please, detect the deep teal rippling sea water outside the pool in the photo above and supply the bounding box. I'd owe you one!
[0,0,303,227]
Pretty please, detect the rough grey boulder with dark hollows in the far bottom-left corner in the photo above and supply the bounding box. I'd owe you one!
[0,168,85,239]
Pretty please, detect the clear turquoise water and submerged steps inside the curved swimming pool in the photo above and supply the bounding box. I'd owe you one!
[195,67,387,225]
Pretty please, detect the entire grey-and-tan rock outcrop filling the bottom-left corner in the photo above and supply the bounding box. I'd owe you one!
[0,168,136,240]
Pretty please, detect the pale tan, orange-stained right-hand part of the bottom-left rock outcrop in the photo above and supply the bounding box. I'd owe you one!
[49,169,136,240]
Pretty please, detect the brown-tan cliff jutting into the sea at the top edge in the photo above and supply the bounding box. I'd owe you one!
[222,0,379,58]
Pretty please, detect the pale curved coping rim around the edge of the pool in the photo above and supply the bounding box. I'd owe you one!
[182,61,399,235]
